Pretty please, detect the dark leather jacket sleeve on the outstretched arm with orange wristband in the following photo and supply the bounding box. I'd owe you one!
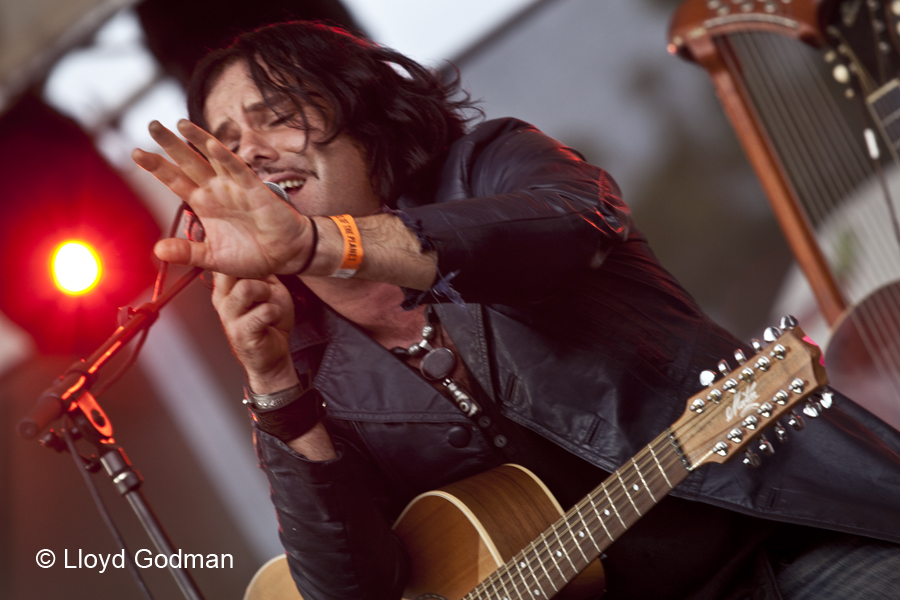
[400,119,631,305]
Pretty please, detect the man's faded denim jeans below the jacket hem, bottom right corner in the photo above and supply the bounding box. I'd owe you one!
[776,535,900,600]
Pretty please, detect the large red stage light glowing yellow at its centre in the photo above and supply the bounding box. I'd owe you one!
[0,97,160,355]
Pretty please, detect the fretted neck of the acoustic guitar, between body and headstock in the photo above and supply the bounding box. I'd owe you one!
[465,428,690,600]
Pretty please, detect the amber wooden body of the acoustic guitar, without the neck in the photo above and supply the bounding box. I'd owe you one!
[244,465,605,600]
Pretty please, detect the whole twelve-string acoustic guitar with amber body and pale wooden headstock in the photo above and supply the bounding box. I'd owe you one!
[244,319,831,600]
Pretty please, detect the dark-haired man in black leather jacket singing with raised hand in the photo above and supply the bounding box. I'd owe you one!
[134,23,900,600]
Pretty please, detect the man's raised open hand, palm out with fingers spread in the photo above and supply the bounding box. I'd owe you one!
[132,120,314,278]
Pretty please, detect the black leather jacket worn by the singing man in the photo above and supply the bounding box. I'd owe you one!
[251,120,900,600]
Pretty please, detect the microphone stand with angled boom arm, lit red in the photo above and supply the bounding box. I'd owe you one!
[17,267,203,600]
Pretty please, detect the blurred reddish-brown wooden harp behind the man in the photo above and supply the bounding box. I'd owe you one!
[669,0,900,429]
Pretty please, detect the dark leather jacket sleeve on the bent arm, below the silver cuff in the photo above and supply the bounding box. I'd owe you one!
[256,430,407,600]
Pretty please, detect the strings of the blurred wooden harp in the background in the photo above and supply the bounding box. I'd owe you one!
[722,32,900,418]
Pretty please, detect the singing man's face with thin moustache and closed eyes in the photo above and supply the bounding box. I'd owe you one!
[204,62,381,216]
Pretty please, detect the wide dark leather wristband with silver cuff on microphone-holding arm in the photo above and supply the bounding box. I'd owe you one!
[244,371,321,442]
